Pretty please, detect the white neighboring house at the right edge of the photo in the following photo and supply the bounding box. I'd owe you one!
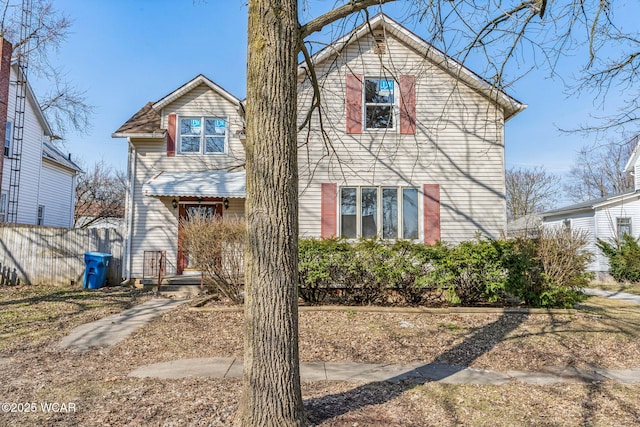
[541,143,640,276]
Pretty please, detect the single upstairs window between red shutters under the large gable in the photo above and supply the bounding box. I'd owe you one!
[364,78,395,129]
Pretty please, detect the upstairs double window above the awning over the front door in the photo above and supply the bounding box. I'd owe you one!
[179,117,228,154]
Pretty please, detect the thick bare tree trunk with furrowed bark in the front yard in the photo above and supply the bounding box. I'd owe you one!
[239,0,306,426]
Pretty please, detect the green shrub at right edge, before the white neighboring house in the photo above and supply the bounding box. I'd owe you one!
[596,234,640,283]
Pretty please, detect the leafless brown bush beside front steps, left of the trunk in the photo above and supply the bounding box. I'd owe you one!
[180,213,246,304]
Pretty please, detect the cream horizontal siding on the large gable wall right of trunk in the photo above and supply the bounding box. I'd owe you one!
[298,36,506,242]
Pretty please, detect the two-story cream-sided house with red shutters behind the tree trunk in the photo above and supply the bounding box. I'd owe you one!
[113,14,526,278]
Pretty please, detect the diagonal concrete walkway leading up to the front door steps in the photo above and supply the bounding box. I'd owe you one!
[59,298,188,351]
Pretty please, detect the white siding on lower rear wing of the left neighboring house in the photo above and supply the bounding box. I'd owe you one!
[38,161,75,228]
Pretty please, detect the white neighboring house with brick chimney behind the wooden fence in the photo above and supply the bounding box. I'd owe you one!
[0,39,80,228]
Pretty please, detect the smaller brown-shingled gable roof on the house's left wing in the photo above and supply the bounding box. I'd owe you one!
[111,74,241,138]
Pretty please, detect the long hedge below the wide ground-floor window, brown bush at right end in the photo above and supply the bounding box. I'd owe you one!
[299,229,591,307]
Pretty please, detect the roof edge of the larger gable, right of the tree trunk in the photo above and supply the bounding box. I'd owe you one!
[298,13,527,121]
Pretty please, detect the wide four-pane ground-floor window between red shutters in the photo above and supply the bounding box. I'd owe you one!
[340,187,418,239]
